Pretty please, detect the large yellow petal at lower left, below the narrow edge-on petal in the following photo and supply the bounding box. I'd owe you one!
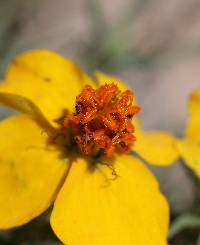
[0,115,68,229]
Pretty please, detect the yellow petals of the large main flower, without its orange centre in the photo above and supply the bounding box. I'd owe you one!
[0,50,177,245]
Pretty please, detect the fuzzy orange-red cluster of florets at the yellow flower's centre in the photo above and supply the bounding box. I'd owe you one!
[63,83,140,157]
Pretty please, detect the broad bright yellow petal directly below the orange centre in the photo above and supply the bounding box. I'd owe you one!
[51,156,168,245]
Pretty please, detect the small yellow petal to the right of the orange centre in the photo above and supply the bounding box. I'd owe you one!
[132,119,179,166]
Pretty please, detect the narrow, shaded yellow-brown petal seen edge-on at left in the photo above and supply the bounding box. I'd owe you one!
[0,92,54,134]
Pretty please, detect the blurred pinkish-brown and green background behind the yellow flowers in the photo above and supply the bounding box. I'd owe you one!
[0,0,200,245]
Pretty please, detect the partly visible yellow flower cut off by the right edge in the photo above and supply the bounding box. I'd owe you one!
[178,89,200,177]
